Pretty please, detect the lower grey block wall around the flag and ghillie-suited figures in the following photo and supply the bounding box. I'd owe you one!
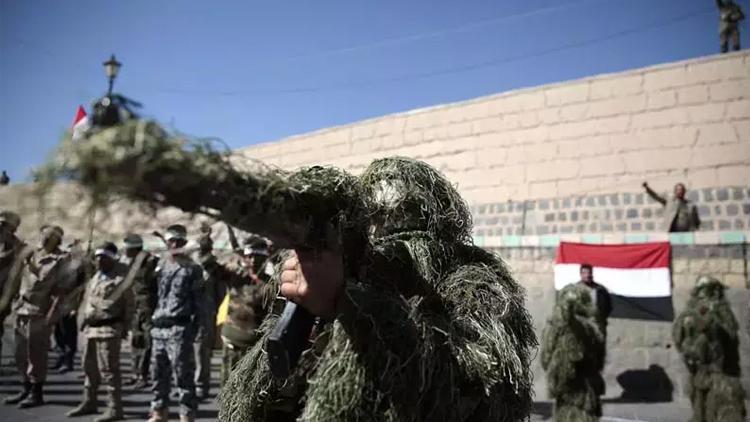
[500,244,750,401]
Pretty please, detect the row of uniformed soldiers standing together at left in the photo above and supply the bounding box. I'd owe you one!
[0,211,275,422]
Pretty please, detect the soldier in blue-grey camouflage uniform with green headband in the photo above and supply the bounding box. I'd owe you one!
[149,224,206,422]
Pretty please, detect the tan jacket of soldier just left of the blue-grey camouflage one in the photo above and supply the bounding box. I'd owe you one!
[81,262,134,338]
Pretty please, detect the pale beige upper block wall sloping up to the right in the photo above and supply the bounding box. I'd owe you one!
[241,51,750,203]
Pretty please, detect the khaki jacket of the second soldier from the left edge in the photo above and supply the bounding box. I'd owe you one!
[15,248,66,316]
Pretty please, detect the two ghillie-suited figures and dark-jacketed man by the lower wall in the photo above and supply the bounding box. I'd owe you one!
[541,264,747,422]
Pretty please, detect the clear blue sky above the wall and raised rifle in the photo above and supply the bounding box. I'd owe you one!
[0,0,748,180]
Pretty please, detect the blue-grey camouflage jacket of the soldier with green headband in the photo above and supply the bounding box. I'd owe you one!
[151,255,206,332]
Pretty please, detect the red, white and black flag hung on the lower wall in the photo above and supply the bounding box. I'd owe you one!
[555,242,674,321]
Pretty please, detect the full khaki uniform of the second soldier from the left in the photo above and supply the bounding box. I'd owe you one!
[15,248,65,384]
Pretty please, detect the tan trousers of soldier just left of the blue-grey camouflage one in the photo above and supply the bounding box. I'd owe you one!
[83,337,122,412]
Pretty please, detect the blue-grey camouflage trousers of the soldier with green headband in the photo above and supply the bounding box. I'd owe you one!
[151,325,198,416]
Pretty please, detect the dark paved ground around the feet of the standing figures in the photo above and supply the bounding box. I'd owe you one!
[0,330,690,422]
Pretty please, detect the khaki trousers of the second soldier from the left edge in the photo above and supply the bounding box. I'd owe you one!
[15,315,50,384]
